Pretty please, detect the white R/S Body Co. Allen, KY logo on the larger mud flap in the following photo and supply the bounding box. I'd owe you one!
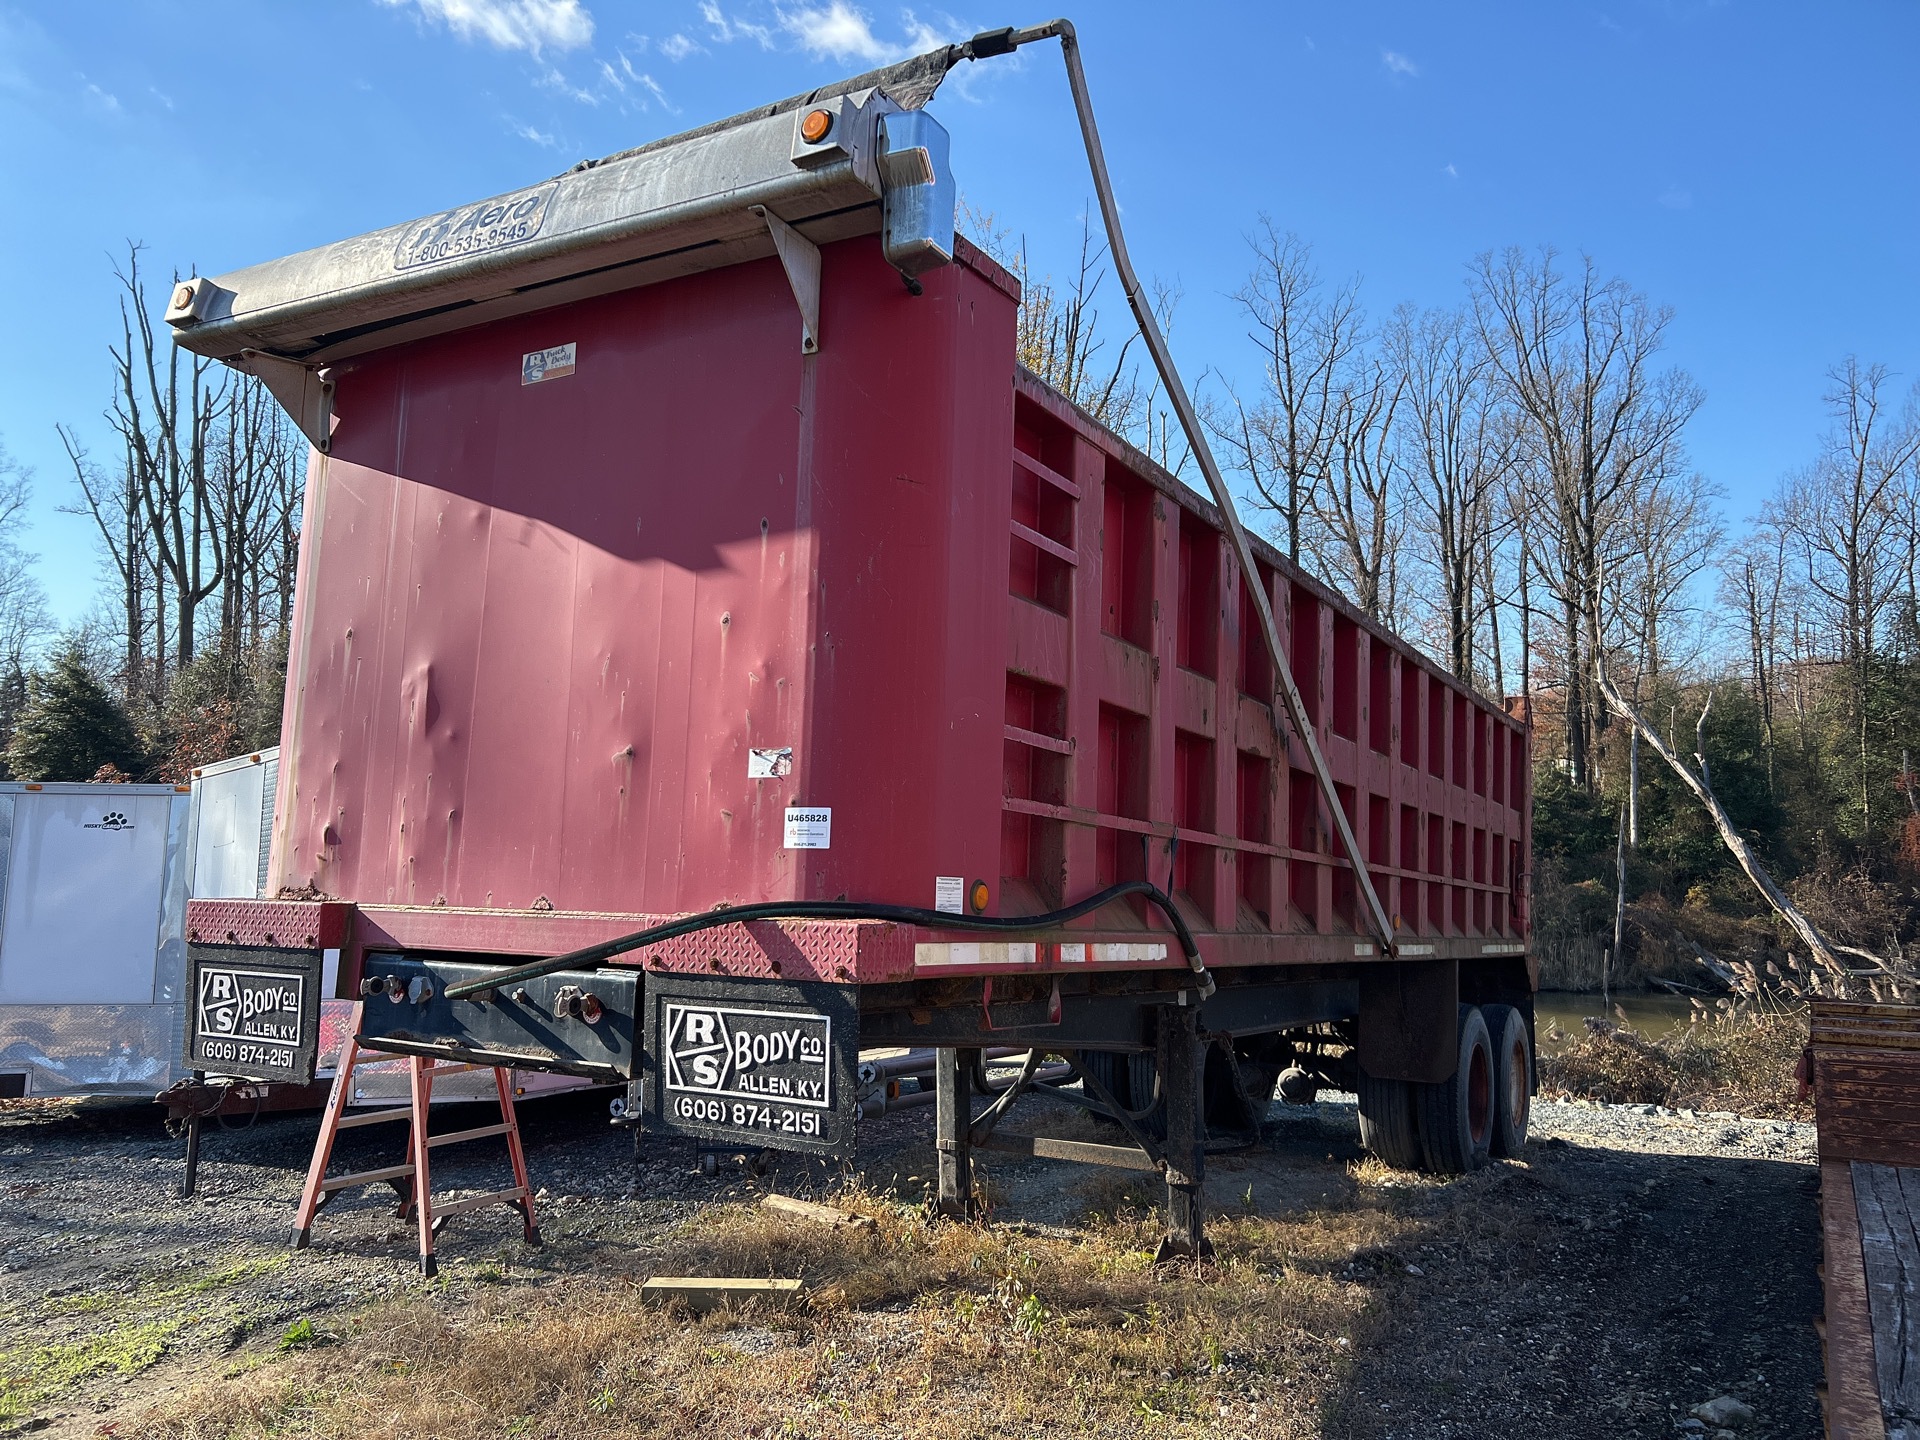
[662,1004,833,1110]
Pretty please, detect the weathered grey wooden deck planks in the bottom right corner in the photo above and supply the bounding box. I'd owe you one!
[1851,1160,1920,1436]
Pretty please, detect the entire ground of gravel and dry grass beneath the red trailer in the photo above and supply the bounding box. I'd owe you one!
[0,1096,1818,1438]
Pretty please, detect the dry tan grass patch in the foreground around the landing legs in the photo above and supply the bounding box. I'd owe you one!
[138,1185,1405,1440]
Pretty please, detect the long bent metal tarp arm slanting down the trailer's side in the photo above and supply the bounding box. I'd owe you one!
[990,19,1396,954]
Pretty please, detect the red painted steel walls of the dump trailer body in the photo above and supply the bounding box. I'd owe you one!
[232,238,1528,981]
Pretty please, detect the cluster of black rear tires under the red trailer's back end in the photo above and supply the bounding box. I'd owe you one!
[1359,1004,1532,1175]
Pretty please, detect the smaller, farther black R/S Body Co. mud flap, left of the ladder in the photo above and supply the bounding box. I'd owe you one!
[186,945,321,1085]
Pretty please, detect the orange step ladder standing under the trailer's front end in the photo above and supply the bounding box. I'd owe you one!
[294,1004,540,1275]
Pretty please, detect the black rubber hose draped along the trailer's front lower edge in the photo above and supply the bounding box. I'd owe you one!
[445,879,1212,1000]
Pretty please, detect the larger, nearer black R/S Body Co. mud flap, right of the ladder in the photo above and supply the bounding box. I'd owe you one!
[645,973,860,1160]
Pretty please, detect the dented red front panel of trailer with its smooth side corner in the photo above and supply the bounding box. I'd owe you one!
[269,229,1014,914]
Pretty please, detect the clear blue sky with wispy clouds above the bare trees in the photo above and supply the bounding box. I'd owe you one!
[0,0,1920,620]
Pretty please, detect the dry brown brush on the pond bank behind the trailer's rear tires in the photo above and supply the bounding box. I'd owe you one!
[1540,1006,1812,1119]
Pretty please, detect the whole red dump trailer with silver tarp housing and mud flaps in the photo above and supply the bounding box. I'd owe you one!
[169,28,1536,1248]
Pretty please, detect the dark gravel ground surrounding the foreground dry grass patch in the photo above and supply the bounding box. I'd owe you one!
[0,1094,1820,1440]
